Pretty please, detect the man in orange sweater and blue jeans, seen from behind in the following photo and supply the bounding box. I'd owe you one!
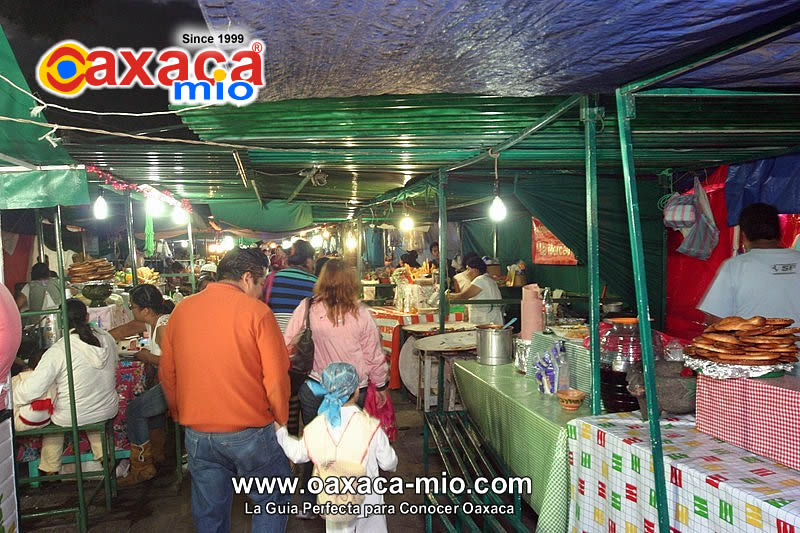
[159,249,291,533]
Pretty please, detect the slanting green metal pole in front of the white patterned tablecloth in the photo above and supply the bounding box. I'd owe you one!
[616,89,669,533]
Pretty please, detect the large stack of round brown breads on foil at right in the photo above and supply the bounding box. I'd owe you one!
[684,316,800,379]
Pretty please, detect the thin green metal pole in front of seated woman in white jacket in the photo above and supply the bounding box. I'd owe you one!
[54,205,88,531]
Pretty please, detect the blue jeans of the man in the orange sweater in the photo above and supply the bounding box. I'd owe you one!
[186,424,292,533]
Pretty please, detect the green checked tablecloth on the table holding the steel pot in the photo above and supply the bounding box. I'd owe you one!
[453,361,589,533]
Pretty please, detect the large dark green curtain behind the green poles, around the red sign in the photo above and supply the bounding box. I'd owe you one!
[516,176,665,326]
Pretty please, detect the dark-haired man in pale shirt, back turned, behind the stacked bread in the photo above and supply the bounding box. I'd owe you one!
[698,203,800,325]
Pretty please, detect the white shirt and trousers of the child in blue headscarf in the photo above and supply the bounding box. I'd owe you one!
[276,405,397,533]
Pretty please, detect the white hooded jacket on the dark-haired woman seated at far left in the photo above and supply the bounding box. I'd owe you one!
[12,329,119,426]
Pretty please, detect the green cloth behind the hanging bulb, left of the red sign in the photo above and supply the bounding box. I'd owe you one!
[461,216,531,265]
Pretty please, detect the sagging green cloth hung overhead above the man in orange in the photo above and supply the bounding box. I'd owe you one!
[209,200,314,232]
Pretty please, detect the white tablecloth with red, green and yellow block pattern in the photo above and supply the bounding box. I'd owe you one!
[568,413,800,533]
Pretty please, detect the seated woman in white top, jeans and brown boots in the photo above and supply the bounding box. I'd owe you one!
[114,284,174,487]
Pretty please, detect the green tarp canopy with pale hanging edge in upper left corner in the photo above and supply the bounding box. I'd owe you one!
[0,28,89,209]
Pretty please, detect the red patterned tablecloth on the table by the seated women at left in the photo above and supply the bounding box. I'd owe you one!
[16,361,144,462]
